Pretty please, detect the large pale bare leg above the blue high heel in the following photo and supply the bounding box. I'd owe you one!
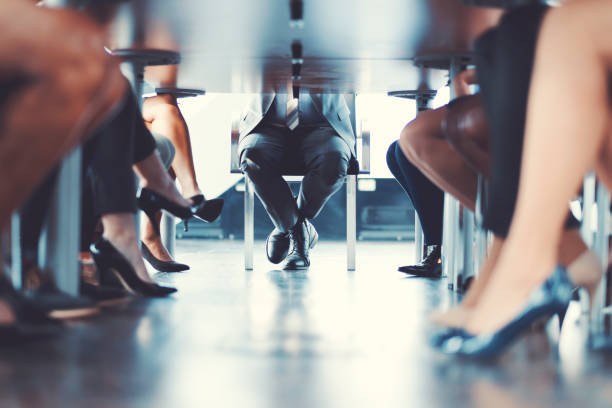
[466,0,612,333]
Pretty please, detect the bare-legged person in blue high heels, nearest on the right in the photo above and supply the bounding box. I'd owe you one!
[444,0,612,356]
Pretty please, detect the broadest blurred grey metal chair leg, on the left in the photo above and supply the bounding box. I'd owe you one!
[41,148,81,295]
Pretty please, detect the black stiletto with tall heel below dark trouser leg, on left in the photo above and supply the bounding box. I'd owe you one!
[89,238,176,297]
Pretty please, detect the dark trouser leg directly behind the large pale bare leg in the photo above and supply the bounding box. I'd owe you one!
[475,5,579,237]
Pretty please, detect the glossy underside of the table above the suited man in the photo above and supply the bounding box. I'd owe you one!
[123,0,501,92]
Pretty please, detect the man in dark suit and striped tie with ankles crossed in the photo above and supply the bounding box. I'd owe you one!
[240,90,355,270]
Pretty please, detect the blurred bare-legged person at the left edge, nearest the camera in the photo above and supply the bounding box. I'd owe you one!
[0,0,126,341]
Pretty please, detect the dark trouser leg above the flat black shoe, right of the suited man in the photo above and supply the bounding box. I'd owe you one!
[387,141,444,245]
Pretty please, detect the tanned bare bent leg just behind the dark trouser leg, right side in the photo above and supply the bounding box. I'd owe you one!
[399,107,478,211]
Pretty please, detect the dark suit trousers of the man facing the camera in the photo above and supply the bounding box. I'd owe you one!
[240,124,351,232]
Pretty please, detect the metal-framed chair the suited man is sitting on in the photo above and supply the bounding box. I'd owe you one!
[230,96,370,271]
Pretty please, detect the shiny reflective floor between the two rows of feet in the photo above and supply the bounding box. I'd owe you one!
[0,241,612,408]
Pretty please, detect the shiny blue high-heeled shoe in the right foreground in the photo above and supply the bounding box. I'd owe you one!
[440,266,573,358]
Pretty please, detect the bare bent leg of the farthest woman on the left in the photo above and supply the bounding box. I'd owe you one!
[142,95,201,197]
